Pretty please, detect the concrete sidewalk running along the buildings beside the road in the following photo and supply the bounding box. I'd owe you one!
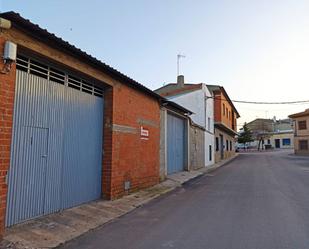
[0,155,237,249]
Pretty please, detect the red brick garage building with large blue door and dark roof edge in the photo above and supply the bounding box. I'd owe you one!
[0,12,188,234]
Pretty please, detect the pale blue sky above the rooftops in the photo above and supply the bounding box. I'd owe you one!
[0,0,309,126]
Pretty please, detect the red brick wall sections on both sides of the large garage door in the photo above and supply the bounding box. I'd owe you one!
[0,37,160,238]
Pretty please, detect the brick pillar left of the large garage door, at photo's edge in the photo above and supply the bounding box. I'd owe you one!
[0,37,16,238]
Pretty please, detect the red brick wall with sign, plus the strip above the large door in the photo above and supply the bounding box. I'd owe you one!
[1,27,160,201]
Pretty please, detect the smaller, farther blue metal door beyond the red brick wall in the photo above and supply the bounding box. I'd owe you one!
[167,114,186,174]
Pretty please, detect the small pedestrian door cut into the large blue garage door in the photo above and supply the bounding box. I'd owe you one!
[9,126,48,224]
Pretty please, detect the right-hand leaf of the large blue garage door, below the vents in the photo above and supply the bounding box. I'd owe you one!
[61,86,103,209]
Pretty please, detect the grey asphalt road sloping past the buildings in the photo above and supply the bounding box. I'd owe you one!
[62,152,309,249]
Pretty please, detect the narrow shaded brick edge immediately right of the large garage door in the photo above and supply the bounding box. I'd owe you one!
[102,87,113,199]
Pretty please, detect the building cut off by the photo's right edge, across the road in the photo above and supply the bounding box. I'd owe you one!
[289,109,309,155]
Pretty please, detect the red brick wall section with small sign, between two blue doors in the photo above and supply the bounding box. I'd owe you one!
[103,85,160,199]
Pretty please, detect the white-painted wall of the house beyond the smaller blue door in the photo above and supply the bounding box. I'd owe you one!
[168,84,215,166]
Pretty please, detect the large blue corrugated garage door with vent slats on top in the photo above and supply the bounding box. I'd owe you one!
[6,57,103,226]
